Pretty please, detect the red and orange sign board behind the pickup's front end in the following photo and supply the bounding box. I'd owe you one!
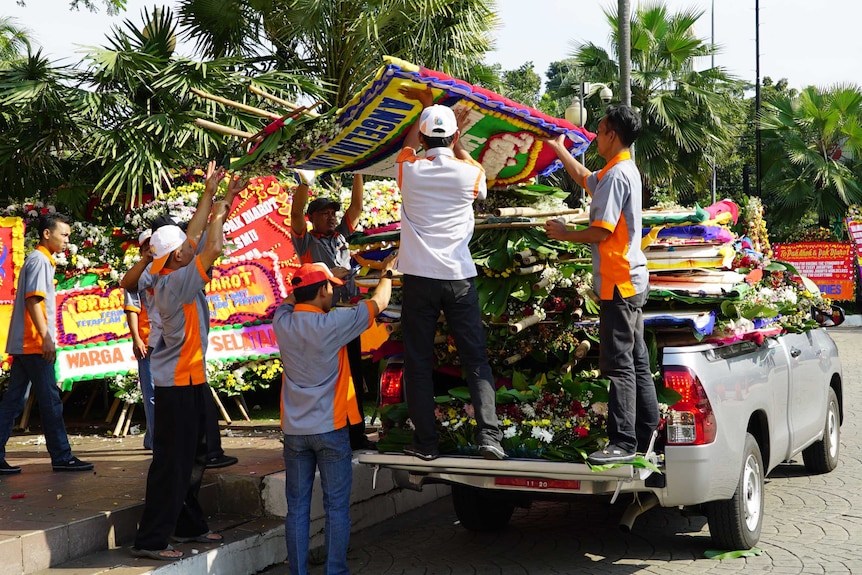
[773,242,856,301]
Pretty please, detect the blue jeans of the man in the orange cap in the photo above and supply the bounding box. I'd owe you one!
[284,427,353,575]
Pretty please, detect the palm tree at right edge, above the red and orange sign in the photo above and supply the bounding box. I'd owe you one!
[760,84,862,232]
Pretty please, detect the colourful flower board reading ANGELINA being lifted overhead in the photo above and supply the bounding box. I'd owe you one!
[297,57,595,186]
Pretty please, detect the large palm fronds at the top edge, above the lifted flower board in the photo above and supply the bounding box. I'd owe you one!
[179,0,497,107]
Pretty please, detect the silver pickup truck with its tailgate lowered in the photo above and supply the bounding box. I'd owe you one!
[359,328,843,549]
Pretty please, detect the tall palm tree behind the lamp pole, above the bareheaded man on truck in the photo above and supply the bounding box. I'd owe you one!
[575,2,742,205]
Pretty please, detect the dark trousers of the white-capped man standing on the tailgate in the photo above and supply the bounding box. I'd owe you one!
[401,275,502,452]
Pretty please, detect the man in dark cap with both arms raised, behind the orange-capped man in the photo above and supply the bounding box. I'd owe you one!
[290,170,374,449]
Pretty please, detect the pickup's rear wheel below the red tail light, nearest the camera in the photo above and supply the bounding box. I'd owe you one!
[706,433,764,550]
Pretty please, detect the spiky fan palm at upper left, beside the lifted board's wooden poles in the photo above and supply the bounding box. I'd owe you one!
[76,8,314,205]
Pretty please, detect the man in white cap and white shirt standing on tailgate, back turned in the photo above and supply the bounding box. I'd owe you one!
[395,88,506,461]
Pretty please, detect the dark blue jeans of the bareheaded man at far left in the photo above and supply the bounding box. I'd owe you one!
[0,353,72,465]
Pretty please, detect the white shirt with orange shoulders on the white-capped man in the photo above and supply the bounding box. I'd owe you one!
[395,147,488,280]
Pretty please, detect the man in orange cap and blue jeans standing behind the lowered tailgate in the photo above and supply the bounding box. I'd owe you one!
[272,255,395,575]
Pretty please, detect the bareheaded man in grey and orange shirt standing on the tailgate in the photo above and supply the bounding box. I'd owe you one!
[545,106,659,465]
